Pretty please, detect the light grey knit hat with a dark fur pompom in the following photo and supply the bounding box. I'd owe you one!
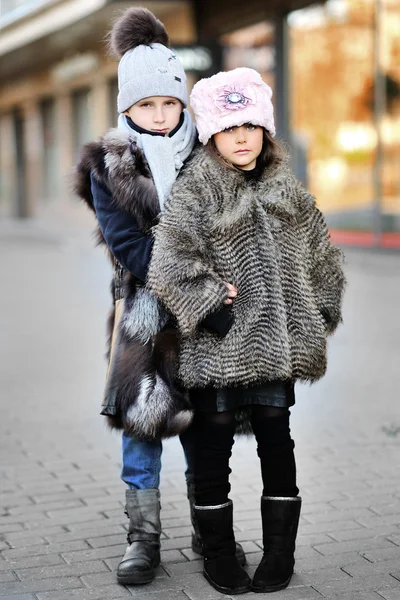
[110,7,188,113]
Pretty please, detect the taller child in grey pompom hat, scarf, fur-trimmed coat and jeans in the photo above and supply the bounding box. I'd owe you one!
[75,7,244,584]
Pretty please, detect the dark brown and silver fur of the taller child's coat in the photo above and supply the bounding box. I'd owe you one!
[74,129,192,439]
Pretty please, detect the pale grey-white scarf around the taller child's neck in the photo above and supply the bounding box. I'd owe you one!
[118,110,197,210]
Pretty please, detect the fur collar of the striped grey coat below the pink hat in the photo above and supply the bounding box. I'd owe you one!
[178,146,298,230]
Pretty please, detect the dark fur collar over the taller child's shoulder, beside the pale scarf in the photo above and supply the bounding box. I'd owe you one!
[73,129,160,233]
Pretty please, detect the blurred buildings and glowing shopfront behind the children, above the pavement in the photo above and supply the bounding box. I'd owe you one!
[0,0,400,247]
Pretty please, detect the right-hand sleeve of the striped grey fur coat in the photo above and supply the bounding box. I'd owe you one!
[299,188,346,334]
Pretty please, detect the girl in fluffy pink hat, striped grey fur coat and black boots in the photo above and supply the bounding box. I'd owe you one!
[148,68,344,594]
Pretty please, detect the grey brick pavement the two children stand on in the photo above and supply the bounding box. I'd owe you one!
[0,221,400,600]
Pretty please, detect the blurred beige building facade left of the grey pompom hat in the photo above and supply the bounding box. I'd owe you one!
[0,0,195,217]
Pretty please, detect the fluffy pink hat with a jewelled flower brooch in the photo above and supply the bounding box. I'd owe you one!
[190,67,275,144]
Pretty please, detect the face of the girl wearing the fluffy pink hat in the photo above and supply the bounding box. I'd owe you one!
[214,123,263,171]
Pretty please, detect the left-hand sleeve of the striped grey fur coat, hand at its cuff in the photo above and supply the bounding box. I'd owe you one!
[148,177,227,336]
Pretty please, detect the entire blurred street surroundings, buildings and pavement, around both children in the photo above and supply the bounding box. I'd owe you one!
[0,7,400,600]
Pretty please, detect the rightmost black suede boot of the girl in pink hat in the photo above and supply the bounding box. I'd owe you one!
[251,496,301,593]
